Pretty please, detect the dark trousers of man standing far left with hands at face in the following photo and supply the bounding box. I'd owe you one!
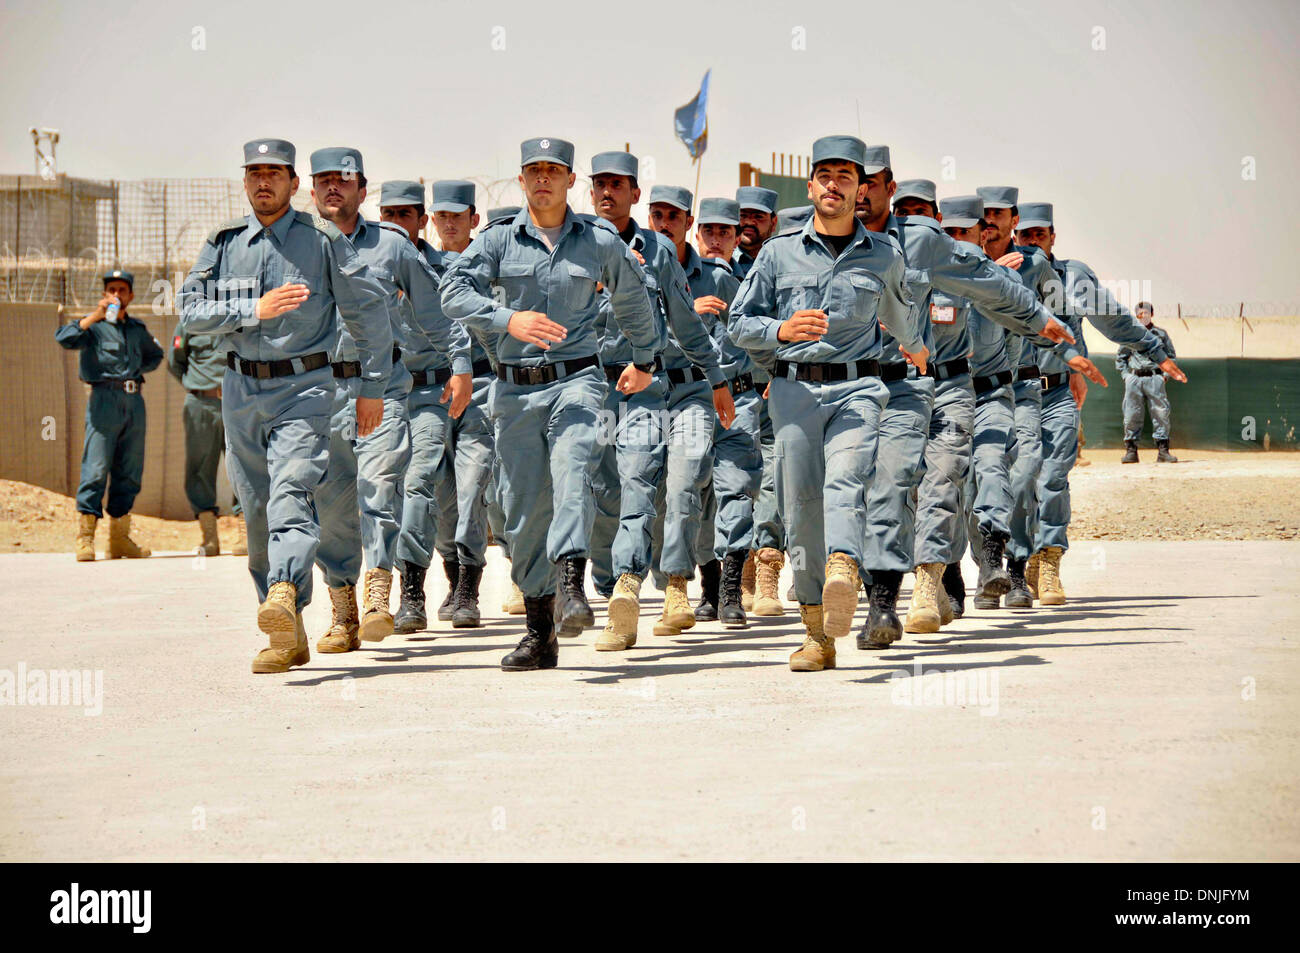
[77,387,144,516]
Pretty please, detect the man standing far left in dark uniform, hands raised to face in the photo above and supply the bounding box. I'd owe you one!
[55,268,163,562]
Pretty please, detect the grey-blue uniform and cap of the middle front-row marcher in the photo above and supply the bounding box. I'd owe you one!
[442,138,658,599]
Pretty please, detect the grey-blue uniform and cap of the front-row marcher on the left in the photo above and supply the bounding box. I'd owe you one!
[179,139,393,611]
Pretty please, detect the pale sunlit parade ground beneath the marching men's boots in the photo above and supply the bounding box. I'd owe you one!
[0,541,1300,861]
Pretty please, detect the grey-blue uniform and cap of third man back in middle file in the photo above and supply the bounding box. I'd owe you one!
[649,180,727,579]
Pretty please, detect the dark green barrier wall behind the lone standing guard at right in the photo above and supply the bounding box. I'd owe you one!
[1083,355,1300,450]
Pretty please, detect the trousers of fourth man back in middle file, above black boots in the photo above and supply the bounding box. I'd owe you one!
[696,389,764,566]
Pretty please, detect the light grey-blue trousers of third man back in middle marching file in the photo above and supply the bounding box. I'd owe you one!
[651,381,718,577]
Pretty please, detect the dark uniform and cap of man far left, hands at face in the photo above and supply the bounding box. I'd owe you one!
[55,268,163,517]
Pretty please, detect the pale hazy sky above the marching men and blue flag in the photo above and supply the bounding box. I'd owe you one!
[0,0,1300,304]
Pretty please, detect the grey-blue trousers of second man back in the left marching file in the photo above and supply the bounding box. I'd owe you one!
[316,378,411,589]
